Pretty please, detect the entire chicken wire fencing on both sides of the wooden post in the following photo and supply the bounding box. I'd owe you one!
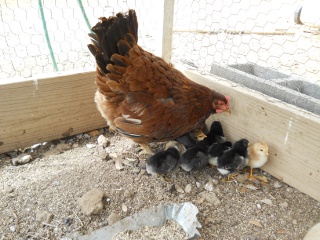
[0,0,320,114]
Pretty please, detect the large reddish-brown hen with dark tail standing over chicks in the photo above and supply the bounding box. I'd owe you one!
[88,10,229,152]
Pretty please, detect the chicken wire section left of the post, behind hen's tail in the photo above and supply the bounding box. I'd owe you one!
[0,0,163,79]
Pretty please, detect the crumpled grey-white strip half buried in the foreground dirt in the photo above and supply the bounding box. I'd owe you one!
[78,202,201,240]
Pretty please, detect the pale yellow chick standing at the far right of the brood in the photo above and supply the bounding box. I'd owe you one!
[247,142,269,180]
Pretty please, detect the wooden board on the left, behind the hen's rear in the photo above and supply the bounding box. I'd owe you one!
[0,72,106,152]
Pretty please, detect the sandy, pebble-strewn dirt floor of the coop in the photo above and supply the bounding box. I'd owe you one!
[0,129,320,240]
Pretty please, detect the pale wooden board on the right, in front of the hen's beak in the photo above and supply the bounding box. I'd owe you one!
[184,67,320,201]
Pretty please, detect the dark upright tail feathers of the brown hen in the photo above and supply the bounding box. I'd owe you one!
[88,10,138,75]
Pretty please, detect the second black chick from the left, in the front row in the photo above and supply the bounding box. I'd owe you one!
[180,139,209,172]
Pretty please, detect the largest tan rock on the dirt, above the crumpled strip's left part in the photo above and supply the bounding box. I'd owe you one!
[78,188,104,216]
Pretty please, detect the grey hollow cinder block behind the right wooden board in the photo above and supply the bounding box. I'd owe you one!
[211,63,320,115]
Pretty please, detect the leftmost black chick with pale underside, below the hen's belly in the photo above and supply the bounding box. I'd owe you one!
[146,147,180,175]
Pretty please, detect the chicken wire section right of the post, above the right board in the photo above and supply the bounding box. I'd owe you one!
[172,0,320,114]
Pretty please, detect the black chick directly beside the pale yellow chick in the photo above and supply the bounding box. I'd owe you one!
[217,139,249,179]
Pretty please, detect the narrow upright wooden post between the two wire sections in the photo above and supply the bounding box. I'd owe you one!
[162,0,174,63]
